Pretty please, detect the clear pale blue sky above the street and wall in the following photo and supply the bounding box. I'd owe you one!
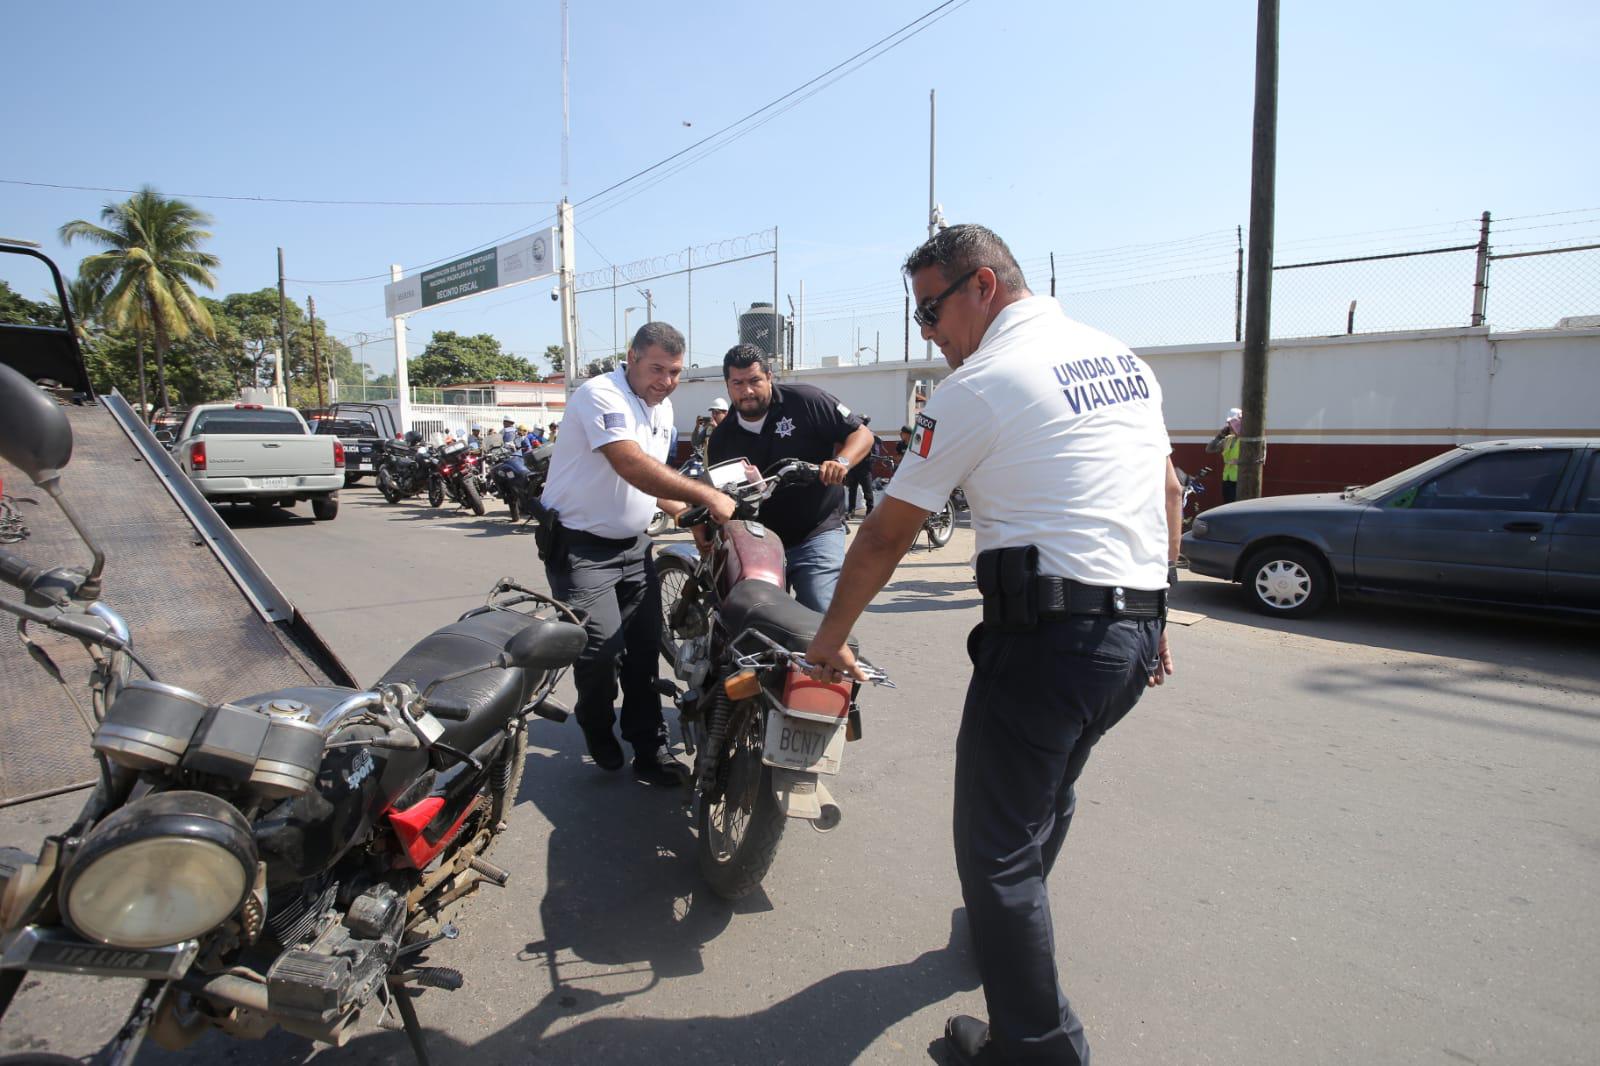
[0,0,1600,371]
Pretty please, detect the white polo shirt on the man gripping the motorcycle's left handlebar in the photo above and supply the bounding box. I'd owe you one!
[542,367,674,539]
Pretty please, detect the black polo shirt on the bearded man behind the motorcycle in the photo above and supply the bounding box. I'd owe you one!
[706,383,861,547]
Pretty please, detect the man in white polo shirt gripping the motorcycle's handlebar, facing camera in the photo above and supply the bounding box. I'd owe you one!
[541,322,733,784]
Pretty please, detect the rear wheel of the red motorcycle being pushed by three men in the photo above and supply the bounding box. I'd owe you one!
[698,707,789,900]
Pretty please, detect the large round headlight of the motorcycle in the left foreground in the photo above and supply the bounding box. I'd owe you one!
[61,792,256,948]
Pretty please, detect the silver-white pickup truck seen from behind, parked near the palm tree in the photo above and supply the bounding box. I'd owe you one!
[171,403,344,520]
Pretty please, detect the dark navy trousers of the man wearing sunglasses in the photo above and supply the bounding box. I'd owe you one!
[955,616,1160,1066]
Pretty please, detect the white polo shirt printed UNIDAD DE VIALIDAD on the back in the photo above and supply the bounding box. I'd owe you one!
[888,296,1171,589]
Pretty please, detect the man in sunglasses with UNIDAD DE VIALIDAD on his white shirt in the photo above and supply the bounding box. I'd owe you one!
[806,226,1182,1064]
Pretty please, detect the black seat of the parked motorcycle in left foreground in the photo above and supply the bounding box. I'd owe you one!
[378,611,539,751]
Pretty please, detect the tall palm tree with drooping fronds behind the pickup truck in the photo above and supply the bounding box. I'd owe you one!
[61,186,219,410]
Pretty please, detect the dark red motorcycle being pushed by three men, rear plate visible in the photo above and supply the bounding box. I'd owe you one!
[656,459,894,900]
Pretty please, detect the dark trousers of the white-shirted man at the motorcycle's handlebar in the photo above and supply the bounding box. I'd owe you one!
[544,530,667,745]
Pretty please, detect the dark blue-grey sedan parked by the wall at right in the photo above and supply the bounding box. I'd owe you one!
[1184,437,1600,616]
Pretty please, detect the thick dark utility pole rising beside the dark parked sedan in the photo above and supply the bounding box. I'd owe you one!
[1238,0,1278,499]
